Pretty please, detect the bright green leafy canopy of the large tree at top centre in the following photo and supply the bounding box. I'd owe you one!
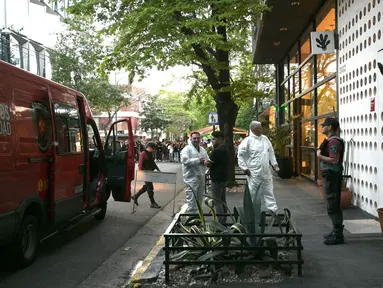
[69,0,266,79]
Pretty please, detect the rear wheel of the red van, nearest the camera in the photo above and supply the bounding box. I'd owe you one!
[12,215,40,268]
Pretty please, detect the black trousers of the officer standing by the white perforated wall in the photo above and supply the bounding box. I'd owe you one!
[322,170,343,226]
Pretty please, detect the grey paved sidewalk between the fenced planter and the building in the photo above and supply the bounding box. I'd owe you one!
[143,178,383,288]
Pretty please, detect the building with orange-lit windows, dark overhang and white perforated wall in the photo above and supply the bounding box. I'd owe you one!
[253,0,383,215]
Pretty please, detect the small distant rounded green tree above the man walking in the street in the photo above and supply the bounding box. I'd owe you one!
[140,96,170,138]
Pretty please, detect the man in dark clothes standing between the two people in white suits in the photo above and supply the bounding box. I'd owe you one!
[206,131,230,224]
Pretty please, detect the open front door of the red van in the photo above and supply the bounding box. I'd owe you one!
[105,118,135,202]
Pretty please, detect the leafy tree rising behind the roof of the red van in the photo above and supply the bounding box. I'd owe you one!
[51,17,128,116]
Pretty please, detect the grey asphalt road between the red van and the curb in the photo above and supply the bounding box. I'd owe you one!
[0,163,182,288]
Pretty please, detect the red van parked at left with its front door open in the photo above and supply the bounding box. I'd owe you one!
[0,61,134,266]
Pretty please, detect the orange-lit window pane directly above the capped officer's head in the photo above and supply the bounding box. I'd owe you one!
[317,78,337,115]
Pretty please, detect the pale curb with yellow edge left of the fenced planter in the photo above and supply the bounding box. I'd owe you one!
[125,204,187,288]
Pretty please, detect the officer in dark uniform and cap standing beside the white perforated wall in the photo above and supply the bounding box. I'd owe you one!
[317,118,344,245]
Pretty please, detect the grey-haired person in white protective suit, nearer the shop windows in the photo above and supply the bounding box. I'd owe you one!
[238,121,279,212]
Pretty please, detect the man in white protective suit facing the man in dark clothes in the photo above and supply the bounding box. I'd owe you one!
[181,132,209,213]
